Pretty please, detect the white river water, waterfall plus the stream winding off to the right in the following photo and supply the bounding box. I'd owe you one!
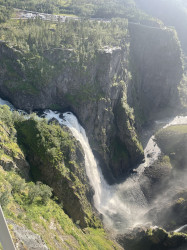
[0,99,187,233]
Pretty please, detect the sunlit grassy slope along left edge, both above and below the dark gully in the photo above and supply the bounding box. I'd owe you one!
[0,106,118,249]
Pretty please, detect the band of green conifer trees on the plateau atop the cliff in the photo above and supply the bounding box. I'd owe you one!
[0,19,127,54]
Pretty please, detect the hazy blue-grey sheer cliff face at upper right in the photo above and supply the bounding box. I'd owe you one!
[128,23,183,123]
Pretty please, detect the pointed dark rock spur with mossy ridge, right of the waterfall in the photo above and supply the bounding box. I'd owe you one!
[111,89,144,177]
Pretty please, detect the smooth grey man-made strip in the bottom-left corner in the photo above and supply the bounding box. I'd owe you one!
[0,206,15,250]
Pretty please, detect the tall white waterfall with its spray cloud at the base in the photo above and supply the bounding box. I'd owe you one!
[45,111,147,231]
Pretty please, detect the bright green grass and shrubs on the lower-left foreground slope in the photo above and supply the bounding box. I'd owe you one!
[0,167,117,250]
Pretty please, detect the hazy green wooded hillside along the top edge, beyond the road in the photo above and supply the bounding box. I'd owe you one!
[0,0,153,19]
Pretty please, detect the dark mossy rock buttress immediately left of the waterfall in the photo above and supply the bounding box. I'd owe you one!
[16,118,101,227]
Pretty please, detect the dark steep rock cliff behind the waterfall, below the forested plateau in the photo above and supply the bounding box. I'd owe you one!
[0,40,143,181]
